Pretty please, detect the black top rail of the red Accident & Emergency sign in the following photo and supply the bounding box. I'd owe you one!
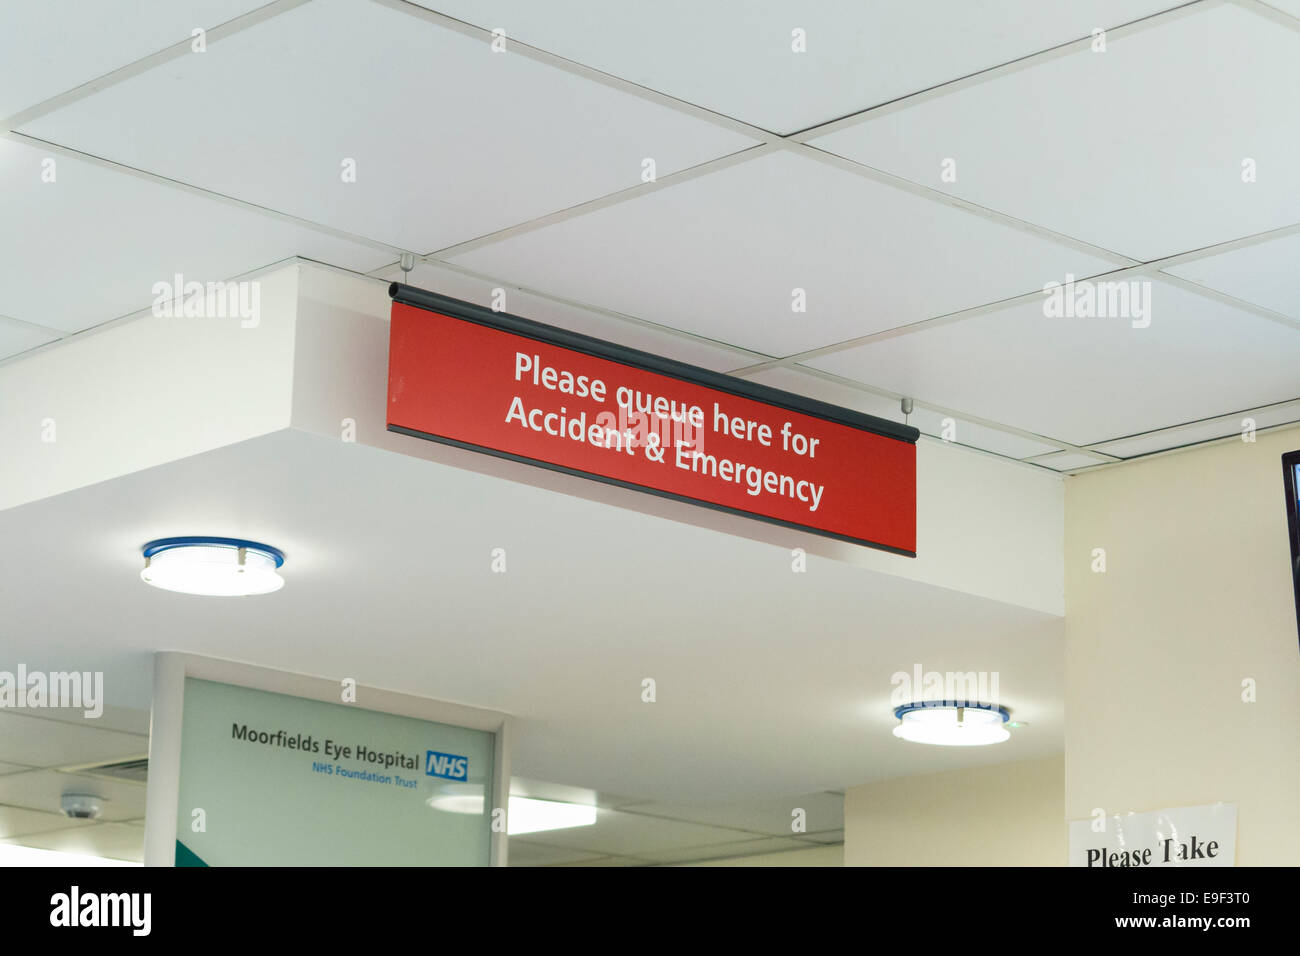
[389,282,920,445]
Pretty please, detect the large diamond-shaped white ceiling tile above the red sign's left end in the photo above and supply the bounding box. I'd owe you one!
[23,0,753,252]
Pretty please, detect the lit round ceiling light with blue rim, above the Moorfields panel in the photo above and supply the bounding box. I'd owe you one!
[140,537,285,597]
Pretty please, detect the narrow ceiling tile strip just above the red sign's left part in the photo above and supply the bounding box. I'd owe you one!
[382,263,763,372]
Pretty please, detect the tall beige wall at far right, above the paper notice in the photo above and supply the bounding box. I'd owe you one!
[1065,428,1300,866]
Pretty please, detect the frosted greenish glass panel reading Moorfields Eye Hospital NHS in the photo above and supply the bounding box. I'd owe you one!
[177,678,495,866]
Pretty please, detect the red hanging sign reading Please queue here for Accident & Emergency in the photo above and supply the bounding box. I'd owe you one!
[387,285,917,555]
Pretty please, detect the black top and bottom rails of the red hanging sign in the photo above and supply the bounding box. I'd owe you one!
[387,282,920,558]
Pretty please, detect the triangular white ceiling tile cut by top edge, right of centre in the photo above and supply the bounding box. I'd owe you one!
[420,0,1175,133]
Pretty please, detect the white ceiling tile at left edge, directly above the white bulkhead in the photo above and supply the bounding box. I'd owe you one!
[0,139,391,332]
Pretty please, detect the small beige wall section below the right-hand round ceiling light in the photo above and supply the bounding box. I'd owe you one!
[844,756,1066,866]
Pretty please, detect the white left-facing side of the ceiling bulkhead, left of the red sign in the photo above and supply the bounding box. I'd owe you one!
[0,265,298,509]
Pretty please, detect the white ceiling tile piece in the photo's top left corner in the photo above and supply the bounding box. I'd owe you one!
[0,0,268,117]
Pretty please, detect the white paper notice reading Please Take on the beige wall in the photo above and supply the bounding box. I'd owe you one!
[1070,804,1236,866]
